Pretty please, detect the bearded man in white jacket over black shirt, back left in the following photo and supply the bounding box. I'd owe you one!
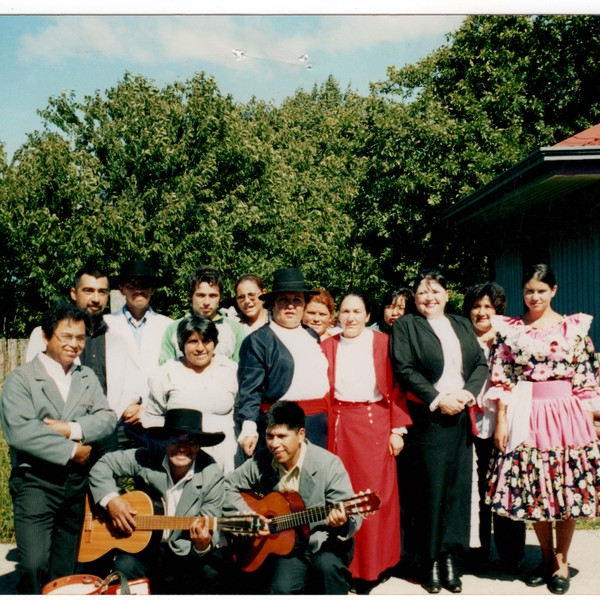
[25,263,147,449]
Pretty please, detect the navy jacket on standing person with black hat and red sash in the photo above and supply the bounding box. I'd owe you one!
[236,323,319,427]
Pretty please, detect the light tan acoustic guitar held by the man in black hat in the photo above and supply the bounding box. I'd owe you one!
[77,490,263,562]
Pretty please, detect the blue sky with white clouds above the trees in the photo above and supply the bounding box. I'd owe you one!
[0,14,464,159]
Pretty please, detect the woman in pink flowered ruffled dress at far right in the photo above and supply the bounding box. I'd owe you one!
[486,265,600,594]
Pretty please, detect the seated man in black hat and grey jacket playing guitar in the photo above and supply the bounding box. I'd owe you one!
[89,408,225,594]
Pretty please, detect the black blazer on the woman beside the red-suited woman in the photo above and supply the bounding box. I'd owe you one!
[390,314,488,404]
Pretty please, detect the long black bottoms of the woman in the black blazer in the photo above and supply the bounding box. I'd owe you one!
[400,402,473,561]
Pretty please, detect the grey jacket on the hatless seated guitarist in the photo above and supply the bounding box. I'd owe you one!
[224,441,362,552]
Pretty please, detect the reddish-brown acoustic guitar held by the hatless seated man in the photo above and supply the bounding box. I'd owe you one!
[234,490,381,572]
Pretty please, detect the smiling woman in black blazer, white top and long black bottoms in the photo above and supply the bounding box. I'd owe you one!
[391,269,488,594]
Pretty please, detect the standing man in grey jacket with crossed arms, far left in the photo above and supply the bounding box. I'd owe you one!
[0,303,117,594]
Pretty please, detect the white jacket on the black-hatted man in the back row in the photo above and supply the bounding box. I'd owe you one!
[104,309,173,383]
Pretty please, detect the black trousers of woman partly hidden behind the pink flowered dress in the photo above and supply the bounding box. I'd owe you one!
[474,437,525,567]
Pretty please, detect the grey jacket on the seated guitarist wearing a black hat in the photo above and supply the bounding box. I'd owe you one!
[89,448,224,556]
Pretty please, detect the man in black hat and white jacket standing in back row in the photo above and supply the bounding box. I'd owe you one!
[106,259,173,390]
